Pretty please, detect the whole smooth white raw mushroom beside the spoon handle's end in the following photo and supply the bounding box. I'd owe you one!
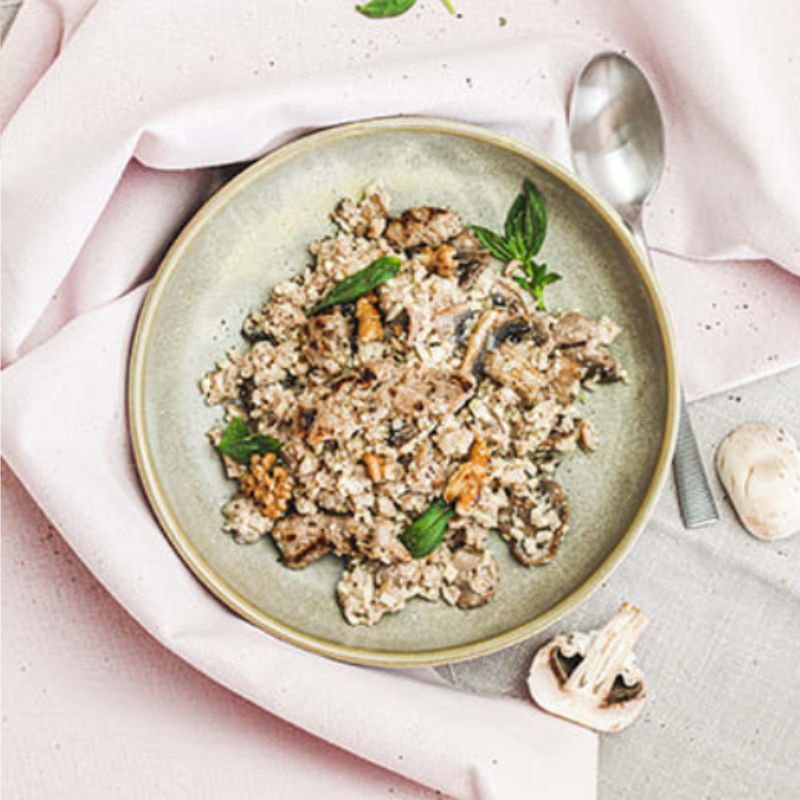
[717,422,800,541]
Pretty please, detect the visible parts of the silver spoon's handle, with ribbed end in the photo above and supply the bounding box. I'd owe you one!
[628,222,719,528]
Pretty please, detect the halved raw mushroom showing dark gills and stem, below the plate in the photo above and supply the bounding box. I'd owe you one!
[528,603,647,731]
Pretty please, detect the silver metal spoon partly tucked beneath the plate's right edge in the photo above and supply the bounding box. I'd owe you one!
[569,53,719,528]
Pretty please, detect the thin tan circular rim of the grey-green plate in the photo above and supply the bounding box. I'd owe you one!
[127,116,678,667]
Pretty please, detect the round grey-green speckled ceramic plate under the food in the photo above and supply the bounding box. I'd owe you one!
[129,118,677,666]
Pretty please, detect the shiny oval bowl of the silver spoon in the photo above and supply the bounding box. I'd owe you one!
[569,53,664,232]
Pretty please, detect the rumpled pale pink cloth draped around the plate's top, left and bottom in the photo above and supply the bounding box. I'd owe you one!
[2,0,800,798]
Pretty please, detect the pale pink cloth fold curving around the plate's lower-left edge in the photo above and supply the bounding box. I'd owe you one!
[2,287,597,800]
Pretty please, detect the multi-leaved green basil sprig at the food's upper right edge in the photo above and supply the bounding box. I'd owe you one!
[472,178,561,311]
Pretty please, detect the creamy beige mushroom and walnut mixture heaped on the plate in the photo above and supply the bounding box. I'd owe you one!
[201,187,626,625]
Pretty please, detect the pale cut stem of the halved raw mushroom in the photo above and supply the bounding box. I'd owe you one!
[566,603,648,697]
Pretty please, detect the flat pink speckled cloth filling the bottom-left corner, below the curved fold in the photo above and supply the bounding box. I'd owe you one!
[0,466,442,800]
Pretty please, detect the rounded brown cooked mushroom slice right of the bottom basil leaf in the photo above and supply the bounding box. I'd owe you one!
[498,481,569,567]
